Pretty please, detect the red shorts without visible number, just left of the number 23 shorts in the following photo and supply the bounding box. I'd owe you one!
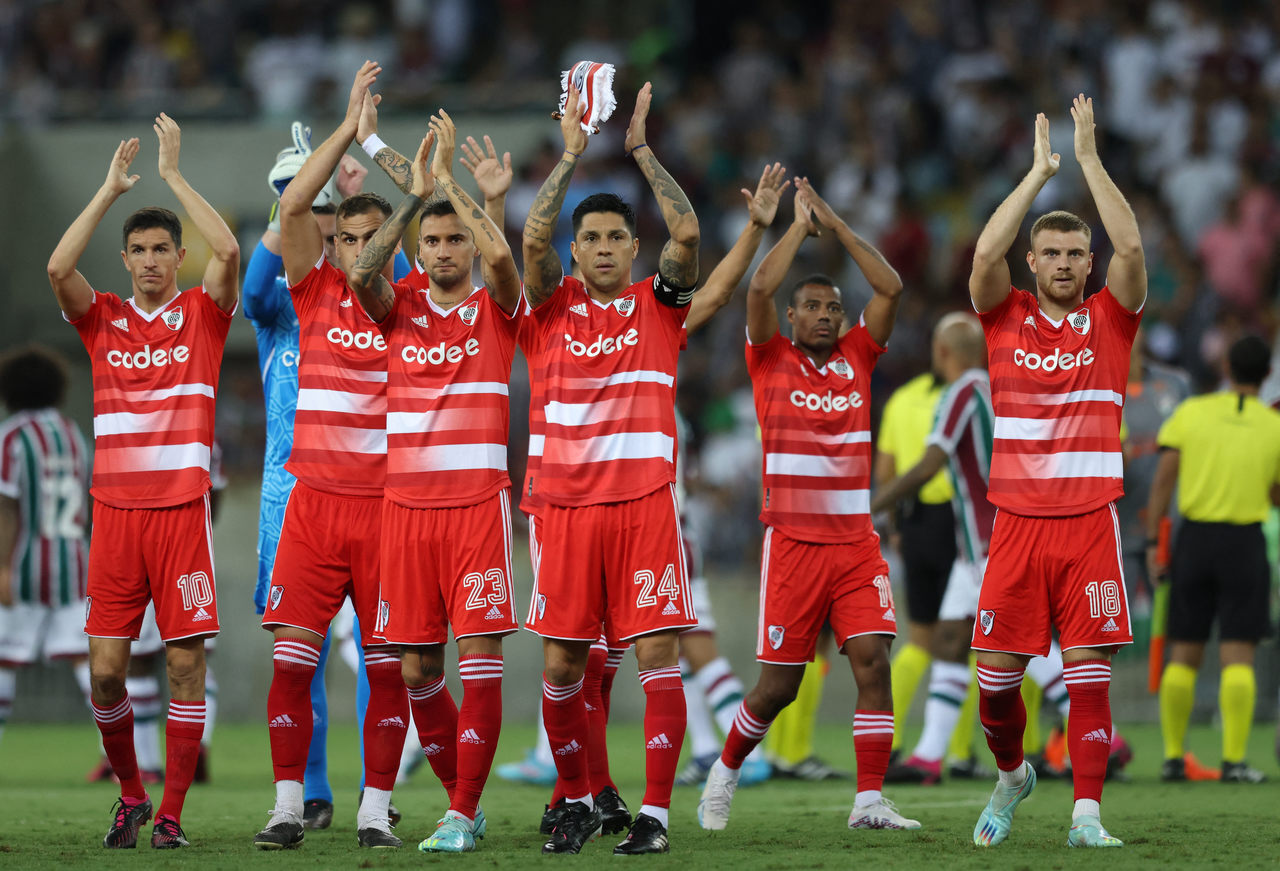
[262,482,383,647]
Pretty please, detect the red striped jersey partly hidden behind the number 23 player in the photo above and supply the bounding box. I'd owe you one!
[284,257,389,496]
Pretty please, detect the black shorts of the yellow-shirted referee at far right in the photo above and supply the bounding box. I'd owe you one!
[1167,520,1271,642]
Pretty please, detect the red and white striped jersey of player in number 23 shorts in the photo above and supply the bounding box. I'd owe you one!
[380,281,524,509]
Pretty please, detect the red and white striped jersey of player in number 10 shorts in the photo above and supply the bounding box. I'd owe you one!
[70,287,236,509]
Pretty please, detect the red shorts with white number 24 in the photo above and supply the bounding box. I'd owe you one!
[525,484,698,646]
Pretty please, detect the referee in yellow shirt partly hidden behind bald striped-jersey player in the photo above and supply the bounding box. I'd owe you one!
[874,361,956,752]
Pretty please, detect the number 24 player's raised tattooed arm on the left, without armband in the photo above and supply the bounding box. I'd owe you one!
[524,83,586,309]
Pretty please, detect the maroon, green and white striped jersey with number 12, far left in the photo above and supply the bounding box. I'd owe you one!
[0,409,88,607]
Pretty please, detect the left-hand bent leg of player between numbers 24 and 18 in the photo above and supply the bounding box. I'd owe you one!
[698,662,805,831]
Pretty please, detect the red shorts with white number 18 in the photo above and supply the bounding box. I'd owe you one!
[973,503,1133,656]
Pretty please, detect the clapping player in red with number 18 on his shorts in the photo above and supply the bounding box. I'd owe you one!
[969,94,1147,847]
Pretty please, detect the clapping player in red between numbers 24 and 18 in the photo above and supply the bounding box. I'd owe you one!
[698,179,920,830]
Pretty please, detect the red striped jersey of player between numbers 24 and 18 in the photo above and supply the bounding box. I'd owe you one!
[746,318,884,543]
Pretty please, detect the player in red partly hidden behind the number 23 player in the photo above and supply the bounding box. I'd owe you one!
[253,61,408,849]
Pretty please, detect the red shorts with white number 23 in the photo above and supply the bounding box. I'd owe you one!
[379,488,520,644]
